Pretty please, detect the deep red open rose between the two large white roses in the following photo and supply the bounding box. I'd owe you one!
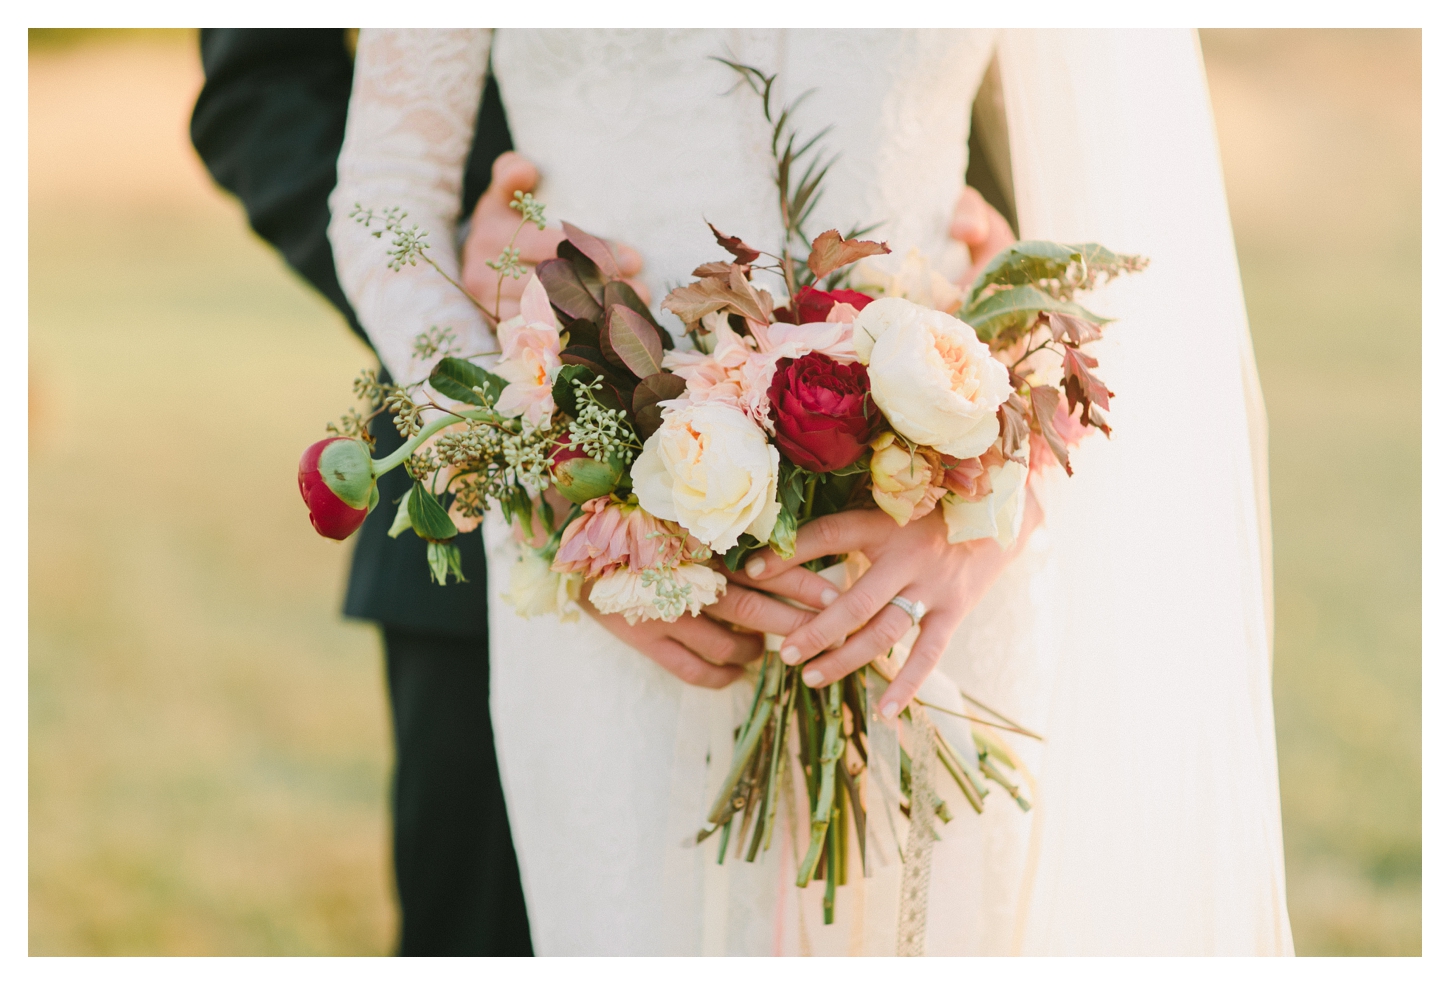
[769,353,880,471]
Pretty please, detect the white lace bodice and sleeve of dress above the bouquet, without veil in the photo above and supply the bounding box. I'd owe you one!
[331,30,993,380]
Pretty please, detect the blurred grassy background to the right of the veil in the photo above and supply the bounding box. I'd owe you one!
[1204,32,1421,955]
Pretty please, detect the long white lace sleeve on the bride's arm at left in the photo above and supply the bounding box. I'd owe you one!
[328,30,494,383]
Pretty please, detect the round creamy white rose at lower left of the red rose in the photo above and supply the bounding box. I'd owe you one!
[629,402,780,553]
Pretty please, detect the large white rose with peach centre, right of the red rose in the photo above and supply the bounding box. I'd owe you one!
[853,297,1012,458]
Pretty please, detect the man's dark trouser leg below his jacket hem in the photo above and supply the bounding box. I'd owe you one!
[383,627,534,956]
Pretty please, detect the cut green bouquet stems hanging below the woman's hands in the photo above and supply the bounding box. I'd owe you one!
[696,651,1035,924]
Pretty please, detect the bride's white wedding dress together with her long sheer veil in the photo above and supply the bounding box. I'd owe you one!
[331,30,1292,955]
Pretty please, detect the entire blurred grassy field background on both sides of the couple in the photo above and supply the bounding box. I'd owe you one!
[29,30,1421,955]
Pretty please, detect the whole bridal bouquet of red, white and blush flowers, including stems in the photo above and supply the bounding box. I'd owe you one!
[299,65,1143,923]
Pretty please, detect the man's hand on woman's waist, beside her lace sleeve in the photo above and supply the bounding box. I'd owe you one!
[463,151,650,321]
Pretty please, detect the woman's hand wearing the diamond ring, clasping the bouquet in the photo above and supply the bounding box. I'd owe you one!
[745,487,1043,718]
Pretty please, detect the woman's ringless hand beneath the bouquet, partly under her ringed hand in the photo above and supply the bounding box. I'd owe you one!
[579,585,829,688]
